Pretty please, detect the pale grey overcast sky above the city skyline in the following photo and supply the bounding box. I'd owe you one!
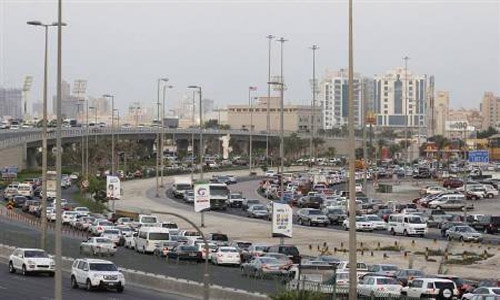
[0,0,500,110]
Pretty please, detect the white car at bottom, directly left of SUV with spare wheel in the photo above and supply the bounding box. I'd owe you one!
[358,276,403,297]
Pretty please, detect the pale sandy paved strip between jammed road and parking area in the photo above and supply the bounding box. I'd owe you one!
[116,170,500,278]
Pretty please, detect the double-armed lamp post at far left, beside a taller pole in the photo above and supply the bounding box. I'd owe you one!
[27,21,66,249]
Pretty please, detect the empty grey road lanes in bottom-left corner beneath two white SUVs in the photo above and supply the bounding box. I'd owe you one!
[0,259,193,300]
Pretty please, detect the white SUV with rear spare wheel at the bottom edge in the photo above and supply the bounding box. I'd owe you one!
[401,277,459,300]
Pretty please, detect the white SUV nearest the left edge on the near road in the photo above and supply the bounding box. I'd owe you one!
[9,248,56,276]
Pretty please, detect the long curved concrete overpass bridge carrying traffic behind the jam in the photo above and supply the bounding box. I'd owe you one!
[0,127,361,169]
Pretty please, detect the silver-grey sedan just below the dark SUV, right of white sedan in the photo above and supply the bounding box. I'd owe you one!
[240,257,288,278]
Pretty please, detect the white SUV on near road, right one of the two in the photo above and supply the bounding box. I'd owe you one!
[71,258,125,293]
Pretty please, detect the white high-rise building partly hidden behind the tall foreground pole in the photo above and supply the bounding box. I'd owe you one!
[319,69,362,129]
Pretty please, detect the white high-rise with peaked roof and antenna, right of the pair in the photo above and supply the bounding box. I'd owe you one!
[374,67,428,129]
